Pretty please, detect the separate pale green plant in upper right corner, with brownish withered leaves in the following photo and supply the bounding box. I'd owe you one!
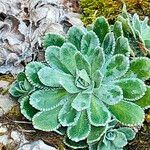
[114,5,150,56]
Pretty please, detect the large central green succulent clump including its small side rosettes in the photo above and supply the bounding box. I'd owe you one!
[10,17,150,150]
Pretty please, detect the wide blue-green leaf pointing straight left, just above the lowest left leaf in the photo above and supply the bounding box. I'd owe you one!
[30,89,67,111]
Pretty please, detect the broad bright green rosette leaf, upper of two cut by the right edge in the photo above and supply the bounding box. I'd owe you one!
[129,57,150,80]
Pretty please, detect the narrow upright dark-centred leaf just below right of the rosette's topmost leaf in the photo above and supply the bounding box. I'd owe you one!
[102,32,115,58]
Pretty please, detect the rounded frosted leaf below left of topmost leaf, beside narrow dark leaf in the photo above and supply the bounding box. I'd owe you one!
[81,31,100,56]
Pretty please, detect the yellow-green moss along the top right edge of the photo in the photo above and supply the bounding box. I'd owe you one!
[80,0,150,25]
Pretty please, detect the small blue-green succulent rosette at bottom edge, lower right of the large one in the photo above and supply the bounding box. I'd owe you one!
[89,120,135,150]
